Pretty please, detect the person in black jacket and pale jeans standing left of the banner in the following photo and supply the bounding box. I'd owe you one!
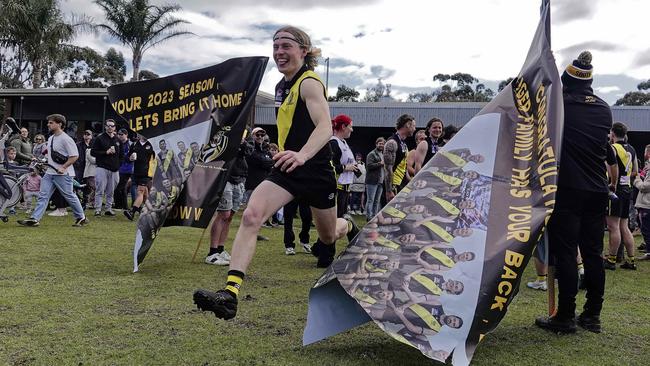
[90,119,122,216]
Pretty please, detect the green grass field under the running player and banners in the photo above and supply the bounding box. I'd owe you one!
[0,212,650,366]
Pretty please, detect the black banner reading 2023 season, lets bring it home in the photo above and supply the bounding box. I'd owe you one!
[108,57,268,272]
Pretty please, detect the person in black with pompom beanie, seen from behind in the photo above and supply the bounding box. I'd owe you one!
[535,51,618,333]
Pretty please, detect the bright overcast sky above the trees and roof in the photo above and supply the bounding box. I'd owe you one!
[61,0,650,103]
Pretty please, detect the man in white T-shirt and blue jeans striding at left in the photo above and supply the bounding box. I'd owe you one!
[18,114,88,226]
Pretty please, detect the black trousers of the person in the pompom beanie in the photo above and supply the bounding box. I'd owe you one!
[548,188,608,319]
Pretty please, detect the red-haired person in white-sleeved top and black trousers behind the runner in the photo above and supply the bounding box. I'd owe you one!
[330,114,359,217]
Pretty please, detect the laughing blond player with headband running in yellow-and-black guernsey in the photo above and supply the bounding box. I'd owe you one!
[194,26,358,319]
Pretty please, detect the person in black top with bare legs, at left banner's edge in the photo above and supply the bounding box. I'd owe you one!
[124,135,156,221]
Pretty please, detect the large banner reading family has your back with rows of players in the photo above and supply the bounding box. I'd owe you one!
[303,1,563,365]
